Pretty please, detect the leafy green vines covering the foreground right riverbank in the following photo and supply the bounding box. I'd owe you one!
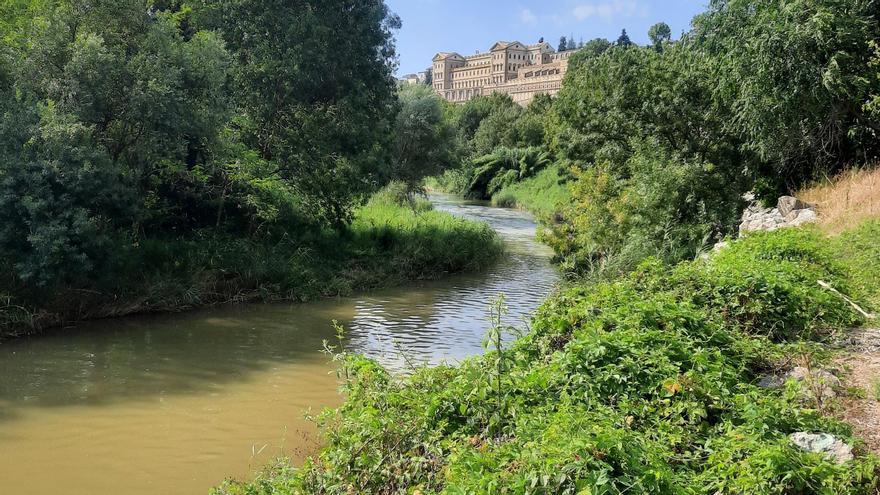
[216,224,880,494]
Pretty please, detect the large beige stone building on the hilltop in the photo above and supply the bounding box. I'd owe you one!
[433,41,575,105]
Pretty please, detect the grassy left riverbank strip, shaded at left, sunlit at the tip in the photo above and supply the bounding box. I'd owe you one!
[0,191,503,340]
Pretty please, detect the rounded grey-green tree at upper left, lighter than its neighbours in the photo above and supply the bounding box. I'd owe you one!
[15,0,231,233]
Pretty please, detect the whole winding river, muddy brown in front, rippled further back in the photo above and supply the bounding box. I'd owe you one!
[0,197,557,495]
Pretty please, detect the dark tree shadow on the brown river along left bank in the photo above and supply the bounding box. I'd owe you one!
[0,301,344,412]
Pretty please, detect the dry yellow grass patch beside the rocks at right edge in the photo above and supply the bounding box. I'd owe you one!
[797,166,880,235]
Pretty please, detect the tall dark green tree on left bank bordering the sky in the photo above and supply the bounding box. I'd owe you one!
[201,0,400,227]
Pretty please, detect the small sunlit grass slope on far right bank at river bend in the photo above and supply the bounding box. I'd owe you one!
[492,166,571,221]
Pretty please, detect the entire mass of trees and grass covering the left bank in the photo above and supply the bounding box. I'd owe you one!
[0,0,502,333]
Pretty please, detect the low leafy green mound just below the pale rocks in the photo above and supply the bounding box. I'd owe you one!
[652,229,861,341]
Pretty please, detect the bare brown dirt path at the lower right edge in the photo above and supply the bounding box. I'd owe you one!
[836,328,880,455]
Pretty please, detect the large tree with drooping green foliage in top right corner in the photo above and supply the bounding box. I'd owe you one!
[693,0,880,186]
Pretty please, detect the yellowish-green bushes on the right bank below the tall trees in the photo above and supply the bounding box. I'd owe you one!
[550,140,742,280]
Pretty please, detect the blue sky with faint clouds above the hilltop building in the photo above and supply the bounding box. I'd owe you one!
[386,0,708,75]
